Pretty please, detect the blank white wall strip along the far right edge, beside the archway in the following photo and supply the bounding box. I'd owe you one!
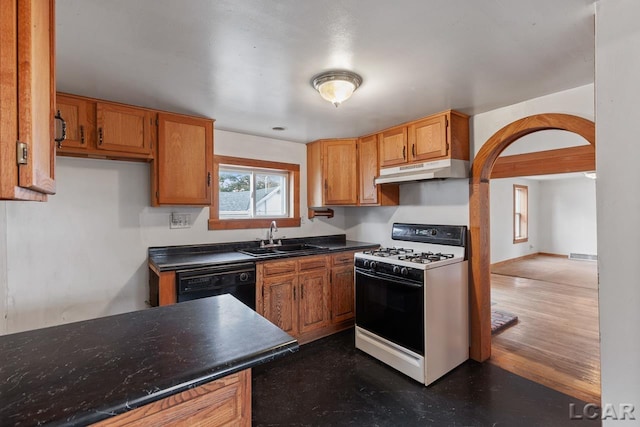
[596,0,640,426]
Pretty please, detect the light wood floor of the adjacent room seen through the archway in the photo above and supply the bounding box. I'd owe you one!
[490,254,600,403]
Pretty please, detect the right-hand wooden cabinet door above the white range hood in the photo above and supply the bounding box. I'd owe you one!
[409,115,449,162]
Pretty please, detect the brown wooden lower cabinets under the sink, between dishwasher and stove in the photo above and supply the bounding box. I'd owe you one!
[256,252,355,344]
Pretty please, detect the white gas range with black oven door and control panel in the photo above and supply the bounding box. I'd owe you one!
[355,223,469,385]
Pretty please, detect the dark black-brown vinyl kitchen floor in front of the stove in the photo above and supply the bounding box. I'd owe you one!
[252,329,600,427]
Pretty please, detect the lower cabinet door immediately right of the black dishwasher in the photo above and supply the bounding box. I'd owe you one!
[262,274,298,336]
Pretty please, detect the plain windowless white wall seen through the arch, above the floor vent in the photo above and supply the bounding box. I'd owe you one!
[538,177,598,255]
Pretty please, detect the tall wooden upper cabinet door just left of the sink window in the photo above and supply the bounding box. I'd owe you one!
[154,113,213,206]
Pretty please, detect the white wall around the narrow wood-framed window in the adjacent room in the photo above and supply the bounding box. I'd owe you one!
[490,178,541,264]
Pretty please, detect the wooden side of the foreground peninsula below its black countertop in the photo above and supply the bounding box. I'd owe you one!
[94,369,251,427]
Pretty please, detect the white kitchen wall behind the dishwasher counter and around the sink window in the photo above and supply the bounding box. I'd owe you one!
[0,131,344,333]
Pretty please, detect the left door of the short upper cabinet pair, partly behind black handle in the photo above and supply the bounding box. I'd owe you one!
[56,95,96,150]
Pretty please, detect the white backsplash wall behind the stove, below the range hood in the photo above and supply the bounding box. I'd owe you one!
[344,179,469,246]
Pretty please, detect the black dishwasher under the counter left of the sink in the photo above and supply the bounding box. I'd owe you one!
[176,262,256,310]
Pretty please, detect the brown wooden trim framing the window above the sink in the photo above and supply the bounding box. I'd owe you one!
[209,156,301,230]
